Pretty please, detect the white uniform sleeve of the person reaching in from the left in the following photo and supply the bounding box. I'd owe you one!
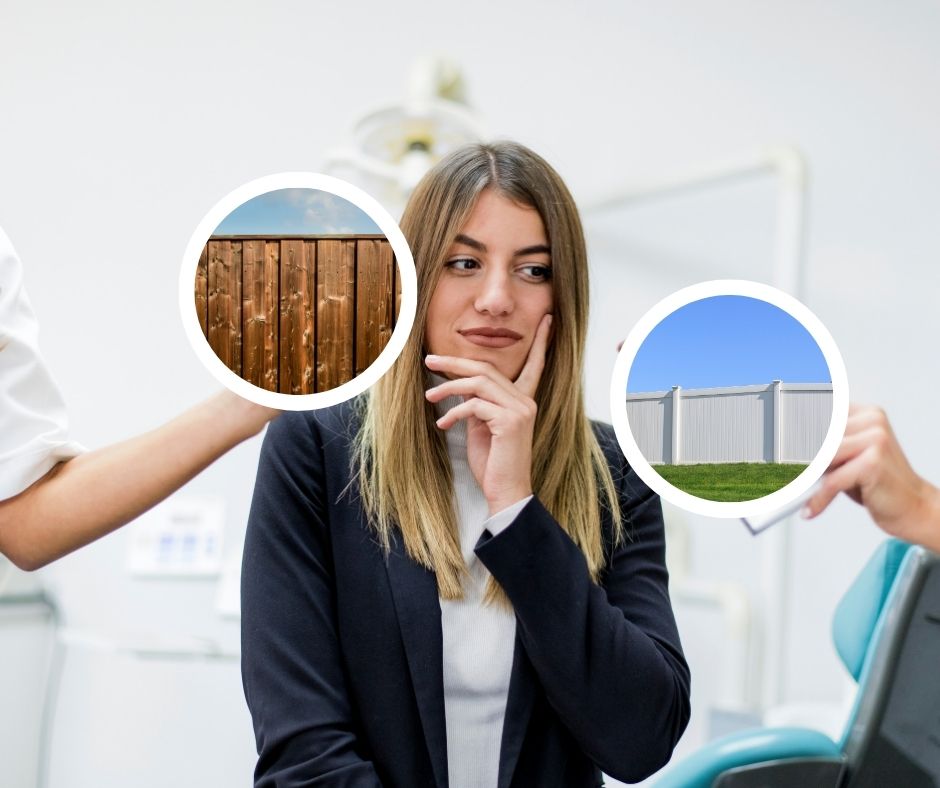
[0,229,84,500]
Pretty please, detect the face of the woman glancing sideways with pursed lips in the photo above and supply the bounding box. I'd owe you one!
[425,189,552,380]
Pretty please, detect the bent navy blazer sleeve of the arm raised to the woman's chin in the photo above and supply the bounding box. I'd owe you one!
[476,428,690,782]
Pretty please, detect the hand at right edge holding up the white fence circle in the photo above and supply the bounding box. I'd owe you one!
[803,405,940,550]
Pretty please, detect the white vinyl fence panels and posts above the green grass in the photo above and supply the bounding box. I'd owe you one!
[627,380,832,465]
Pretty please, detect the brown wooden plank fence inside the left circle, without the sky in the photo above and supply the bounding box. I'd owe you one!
[195,235,401,394]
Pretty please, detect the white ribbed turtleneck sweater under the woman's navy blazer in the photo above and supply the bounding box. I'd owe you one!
[431,375,531,788]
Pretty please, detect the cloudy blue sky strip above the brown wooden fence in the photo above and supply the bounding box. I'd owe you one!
[214,189,382,235]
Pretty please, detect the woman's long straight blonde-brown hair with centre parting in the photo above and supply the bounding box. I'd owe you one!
[353,142,622,601]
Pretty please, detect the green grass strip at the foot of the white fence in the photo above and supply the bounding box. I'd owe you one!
[654,462,806,501]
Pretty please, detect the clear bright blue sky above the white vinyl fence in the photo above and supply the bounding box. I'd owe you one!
[627,295,831,394]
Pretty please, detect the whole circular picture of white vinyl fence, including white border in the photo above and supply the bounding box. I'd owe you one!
[611,281,848,518]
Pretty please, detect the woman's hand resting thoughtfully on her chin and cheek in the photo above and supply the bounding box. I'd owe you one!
[425,315,552,515]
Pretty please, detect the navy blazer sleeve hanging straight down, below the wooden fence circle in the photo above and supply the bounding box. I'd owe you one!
[241,413,381,788]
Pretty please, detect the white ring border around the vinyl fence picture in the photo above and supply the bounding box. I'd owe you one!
[610,279,849,518]
